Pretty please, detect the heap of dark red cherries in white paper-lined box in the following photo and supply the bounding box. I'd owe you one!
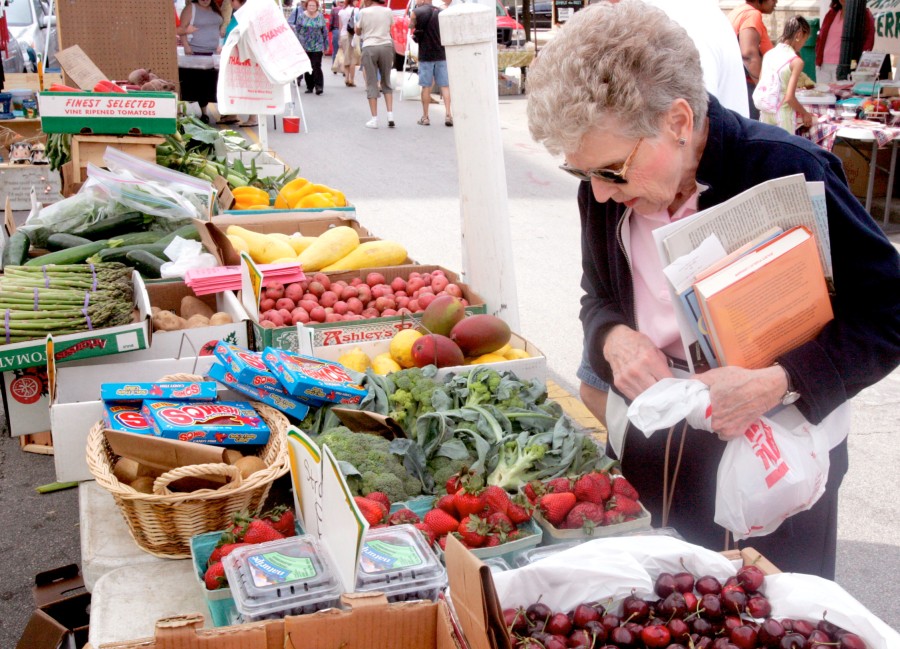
[503,565,866,649]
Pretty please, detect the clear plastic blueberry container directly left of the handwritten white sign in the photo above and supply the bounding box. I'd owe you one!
[222,535,343,622]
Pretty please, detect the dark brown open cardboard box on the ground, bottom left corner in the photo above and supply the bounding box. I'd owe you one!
[16,563,91,649]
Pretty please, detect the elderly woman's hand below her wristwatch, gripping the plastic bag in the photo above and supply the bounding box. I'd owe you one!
[693,366,788,440]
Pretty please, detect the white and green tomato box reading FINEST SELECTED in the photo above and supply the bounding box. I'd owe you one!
[38,92,178,135]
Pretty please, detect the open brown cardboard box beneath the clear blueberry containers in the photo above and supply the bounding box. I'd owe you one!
[98,593,461,649]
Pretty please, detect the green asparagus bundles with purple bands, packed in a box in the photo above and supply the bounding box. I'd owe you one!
[0,263,134,344]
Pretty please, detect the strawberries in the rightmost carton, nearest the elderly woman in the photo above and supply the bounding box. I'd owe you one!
[522,471,643,535]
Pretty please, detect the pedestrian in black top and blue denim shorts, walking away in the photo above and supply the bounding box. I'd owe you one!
[409,0,453,126]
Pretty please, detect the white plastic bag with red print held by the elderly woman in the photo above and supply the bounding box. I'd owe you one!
[628,379,850,539]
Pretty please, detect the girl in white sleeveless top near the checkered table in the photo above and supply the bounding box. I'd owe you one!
[753,16,815,135]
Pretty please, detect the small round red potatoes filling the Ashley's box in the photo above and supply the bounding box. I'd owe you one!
[259,270,469,330]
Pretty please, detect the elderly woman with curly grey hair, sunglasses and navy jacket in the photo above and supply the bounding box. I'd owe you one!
[528,0,900,578]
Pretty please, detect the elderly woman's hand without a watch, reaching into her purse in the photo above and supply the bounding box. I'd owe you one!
[603,325,672,399]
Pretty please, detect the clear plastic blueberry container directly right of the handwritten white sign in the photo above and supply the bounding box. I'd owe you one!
[356,525,447,602]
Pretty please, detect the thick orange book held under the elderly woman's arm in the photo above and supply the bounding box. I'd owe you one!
[694,226,834,369]
